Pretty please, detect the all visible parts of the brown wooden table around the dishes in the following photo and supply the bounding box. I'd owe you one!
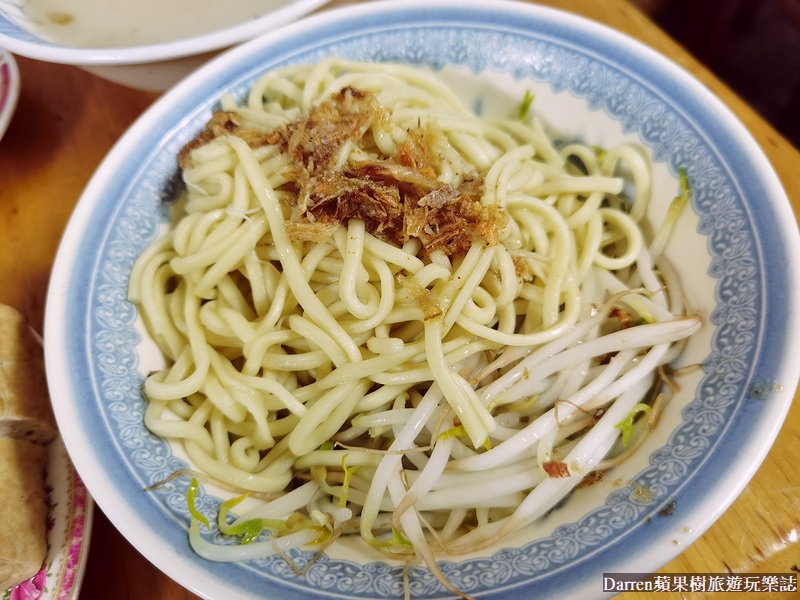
[0,0,800,600]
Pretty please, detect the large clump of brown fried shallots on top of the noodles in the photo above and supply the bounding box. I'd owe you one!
[178,88,501,255]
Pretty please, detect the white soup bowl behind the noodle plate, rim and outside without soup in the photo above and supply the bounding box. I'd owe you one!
[0,0,329,92]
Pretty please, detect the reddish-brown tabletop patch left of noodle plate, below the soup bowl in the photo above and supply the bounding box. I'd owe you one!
[0,57,156,331]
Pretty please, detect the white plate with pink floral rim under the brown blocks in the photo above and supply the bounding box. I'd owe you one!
[0,437,94,600]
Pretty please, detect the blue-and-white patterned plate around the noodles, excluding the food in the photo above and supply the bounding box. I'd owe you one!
[46,0,800,600]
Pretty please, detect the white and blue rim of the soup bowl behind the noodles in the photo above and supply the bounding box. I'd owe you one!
[0,0,330,66]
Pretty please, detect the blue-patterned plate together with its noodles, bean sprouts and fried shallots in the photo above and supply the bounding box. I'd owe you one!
[45,1,800,599]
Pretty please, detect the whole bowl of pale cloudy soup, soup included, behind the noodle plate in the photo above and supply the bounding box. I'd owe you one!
[0,0,327,91]
